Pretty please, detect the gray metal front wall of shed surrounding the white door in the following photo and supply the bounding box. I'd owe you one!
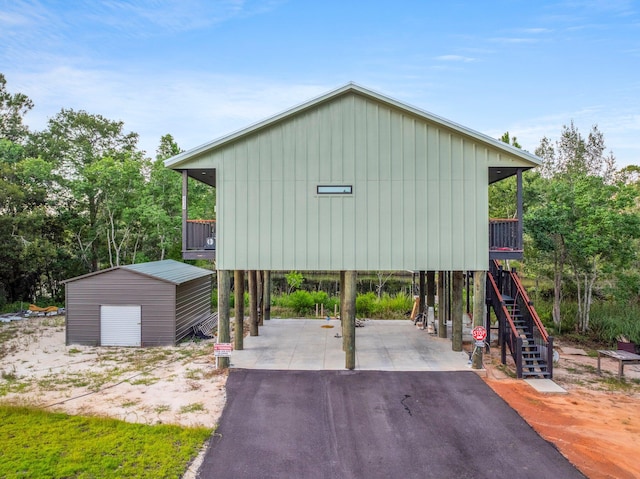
[66,269,176,346]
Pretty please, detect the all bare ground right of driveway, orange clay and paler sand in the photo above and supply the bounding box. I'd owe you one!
[485,344,640,479]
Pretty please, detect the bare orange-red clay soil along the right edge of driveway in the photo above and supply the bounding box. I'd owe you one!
[486,370,640,479]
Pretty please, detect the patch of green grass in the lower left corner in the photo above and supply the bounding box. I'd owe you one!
[0,406,212,479]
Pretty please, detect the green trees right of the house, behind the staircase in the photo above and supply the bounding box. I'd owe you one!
[489,129,640,339]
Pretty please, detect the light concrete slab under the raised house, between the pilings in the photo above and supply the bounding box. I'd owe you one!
[231,319,469,371]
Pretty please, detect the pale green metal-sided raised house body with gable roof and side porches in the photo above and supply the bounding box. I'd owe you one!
[165,83,552,376]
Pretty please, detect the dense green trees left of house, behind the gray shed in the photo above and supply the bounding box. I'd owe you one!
[0,74,215,306]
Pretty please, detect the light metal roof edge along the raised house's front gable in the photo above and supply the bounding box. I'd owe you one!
[164,83,542,169]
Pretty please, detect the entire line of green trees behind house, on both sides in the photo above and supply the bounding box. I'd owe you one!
[0,73,640,340]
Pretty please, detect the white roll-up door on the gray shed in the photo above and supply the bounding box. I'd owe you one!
[100,305,142,346]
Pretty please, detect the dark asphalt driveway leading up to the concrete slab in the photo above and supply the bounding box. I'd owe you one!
[199,369,584,479]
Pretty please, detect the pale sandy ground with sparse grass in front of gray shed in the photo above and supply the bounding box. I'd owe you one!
[0,317,226,428]
